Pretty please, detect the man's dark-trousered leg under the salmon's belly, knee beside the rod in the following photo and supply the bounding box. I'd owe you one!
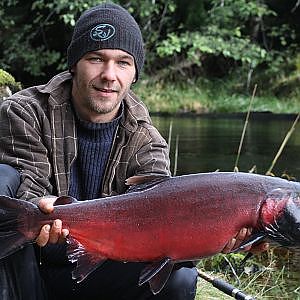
[41,260,197,300]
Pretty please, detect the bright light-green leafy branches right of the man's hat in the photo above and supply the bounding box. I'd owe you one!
[157,0,273,67]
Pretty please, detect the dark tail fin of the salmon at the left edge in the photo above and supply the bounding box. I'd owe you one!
[0,196,35,259]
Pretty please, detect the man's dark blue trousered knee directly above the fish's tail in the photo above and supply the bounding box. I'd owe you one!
[0,164,20,197]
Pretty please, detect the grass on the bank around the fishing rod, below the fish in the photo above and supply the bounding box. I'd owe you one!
[196,249,300,300]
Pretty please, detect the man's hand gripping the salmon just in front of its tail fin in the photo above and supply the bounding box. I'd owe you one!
[36,197,69,247]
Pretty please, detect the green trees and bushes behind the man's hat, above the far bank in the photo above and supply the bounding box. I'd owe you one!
[0,0,300,97]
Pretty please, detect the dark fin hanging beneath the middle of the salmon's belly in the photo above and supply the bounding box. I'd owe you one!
[139,258,174,295]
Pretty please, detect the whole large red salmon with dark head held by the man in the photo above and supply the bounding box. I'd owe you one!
[0,172,300,294]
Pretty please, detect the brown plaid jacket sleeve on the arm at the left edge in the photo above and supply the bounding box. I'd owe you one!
[0,97,53,202]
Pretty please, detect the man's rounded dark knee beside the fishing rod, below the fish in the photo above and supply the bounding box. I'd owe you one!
[157,267,198,300]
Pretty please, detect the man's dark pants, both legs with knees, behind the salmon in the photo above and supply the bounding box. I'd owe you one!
[0,164,197,300]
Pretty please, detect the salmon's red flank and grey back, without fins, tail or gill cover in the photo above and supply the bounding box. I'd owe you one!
[38,173,299,261]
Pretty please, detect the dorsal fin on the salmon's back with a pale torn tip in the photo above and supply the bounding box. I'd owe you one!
[125,175,170,193]
